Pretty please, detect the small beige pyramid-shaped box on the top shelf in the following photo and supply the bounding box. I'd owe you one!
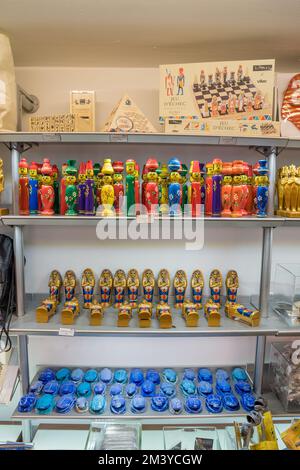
[102,95,157,133]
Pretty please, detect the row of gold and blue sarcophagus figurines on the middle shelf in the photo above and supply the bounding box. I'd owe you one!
[36,268,260,328]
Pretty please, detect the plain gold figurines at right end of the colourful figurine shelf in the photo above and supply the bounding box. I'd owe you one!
[276,165,300,217]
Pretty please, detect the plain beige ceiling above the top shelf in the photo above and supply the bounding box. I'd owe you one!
[0,0,300,71]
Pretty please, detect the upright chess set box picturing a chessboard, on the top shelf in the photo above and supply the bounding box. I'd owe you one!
[159,59,275,129]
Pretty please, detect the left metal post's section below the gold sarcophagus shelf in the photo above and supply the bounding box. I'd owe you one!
[18,335,33,442]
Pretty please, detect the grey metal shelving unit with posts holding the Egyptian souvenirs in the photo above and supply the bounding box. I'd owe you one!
[0,133,300,442]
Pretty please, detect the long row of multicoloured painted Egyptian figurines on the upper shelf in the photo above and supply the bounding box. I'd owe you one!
[19,158,268,217]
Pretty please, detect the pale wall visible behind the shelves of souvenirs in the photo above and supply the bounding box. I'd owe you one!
[4,67,300,378]
